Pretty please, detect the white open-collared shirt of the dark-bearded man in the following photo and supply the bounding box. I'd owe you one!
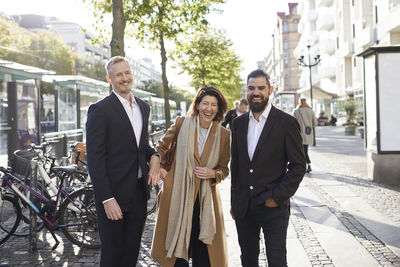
[247,103,271,160]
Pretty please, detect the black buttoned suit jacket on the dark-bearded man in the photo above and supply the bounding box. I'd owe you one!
[231,106,306,218]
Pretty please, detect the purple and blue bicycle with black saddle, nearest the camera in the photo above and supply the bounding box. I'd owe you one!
[0,167,100,250]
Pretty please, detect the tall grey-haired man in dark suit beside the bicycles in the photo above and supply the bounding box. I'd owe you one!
[86,56,160,267]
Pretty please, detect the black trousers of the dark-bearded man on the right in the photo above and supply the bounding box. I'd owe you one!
[235,205,290,267]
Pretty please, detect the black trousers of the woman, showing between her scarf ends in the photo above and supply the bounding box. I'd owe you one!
[174,197,211,267]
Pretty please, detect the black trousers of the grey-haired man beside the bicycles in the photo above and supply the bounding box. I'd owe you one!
[96,183,147,267]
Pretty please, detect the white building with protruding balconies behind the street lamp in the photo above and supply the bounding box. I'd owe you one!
[294,0,337,116]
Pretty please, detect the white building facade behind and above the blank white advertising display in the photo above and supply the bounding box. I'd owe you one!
[335,0,400,121]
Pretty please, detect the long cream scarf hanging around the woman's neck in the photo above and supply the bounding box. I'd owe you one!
[165,116,221,260]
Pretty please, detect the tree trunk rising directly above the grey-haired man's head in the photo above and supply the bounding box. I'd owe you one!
[110,0,126,57]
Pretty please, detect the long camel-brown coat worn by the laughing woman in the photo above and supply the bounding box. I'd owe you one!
[151,119,231,267]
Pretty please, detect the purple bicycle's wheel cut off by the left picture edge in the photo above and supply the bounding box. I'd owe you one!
[0,195,21,245]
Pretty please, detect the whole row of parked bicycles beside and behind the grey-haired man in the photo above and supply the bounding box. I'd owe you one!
[0,142,161,249]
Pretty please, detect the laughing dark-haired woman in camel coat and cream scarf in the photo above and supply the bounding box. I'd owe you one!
[151,87,230,267]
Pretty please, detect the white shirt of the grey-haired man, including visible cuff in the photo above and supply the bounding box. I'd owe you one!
[103,90,143,204]
